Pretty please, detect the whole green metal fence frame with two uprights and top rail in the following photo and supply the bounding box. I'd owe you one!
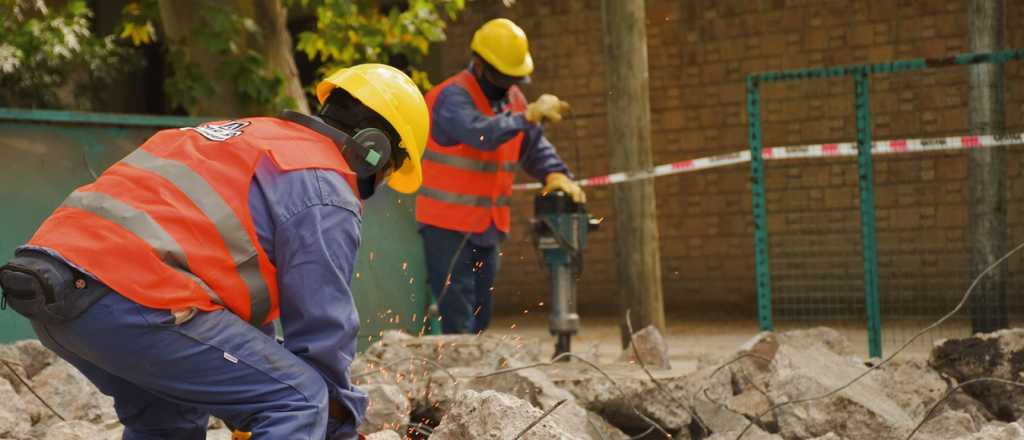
[746,50,1024,357]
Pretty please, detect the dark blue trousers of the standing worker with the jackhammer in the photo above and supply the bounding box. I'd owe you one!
[420,226,501,334]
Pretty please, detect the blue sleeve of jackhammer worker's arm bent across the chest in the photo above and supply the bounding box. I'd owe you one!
[430,86,536,151]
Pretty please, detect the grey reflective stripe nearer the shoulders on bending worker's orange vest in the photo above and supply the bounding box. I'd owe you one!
[122,148,270,325]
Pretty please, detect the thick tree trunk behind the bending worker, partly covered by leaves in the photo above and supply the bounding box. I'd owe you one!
[160,0,309,117]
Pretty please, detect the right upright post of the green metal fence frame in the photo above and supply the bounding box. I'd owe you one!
[854,70,882,357]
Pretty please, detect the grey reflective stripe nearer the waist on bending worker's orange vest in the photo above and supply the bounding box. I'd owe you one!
[60,191,224,305]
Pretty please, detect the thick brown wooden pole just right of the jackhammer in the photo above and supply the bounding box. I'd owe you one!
[601,0,665,347]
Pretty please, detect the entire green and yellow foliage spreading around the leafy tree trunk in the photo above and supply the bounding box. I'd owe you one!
[0,0,466,113]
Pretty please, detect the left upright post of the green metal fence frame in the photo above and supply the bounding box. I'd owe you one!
[746,76,775,331]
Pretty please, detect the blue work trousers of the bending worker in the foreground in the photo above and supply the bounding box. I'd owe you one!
[33,280,355,440]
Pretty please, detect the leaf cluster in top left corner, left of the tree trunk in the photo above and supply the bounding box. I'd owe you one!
[0,0,134,109]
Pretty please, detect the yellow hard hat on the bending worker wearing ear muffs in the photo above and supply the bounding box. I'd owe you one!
[316,64,430,194]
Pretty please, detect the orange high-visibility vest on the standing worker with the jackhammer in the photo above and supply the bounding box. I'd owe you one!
[416,71,526,232]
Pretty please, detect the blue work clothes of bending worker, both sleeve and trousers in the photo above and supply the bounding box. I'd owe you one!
[23,159,368,440]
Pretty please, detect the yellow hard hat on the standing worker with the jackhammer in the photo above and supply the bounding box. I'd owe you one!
[469,18,534,77]
